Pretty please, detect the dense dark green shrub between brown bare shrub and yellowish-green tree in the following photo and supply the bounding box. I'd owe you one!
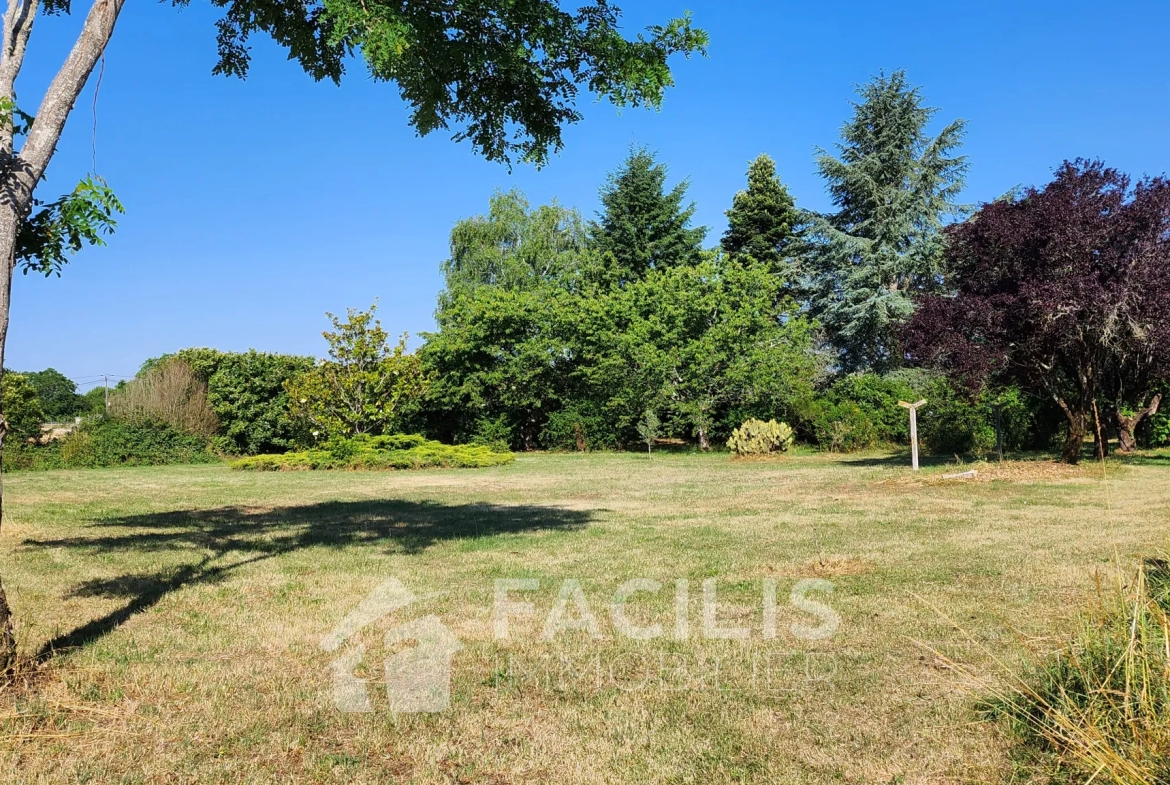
[164,349,314,455]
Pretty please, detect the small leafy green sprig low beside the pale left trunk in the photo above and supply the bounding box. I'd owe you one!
[16,177,125,276]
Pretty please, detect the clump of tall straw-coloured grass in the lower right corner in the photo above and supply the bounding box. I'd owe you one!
[984,559,1170,785]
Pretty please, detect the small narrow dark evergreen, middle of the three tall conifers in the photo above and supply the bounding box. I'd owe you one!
[722,154,800,271]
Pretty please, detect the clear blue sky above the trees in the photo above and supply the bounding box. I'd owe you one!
[7,0,1170,393]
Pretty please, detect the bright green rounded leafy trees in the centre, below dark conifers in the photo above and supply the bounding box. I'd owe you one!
[419,182,820,449]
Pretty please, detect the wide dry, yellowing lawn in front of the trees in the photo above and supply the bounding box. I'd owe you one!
[0,455,1170,784]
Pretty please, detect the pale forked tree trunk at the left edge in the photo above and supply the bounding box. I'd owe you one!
[0,0,125,673]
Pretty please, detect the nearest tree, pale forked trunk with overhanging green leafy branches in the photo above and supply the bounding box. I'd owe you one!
[0,0,707,673]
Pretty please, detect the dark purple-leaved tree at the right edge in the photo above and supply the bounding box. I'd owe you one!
[903,159,1170,463]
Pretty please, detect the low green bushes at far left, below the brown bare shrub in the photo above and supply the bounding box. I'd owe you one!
[4,416,219,471]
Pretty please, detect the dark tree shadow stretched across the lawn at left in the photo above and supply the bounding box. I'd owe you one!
[21,500,593,661]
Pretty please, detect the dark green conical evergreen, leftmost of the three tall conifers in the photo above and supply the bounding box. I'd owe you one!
[590,149,707,283]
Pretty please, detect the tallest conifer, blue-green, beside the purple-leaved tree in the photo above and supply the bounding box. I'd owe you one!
[808,71,966,371]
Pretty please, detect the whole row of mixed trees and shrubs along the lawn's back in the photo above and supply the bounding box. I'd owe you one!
[6,71,1170,461]
